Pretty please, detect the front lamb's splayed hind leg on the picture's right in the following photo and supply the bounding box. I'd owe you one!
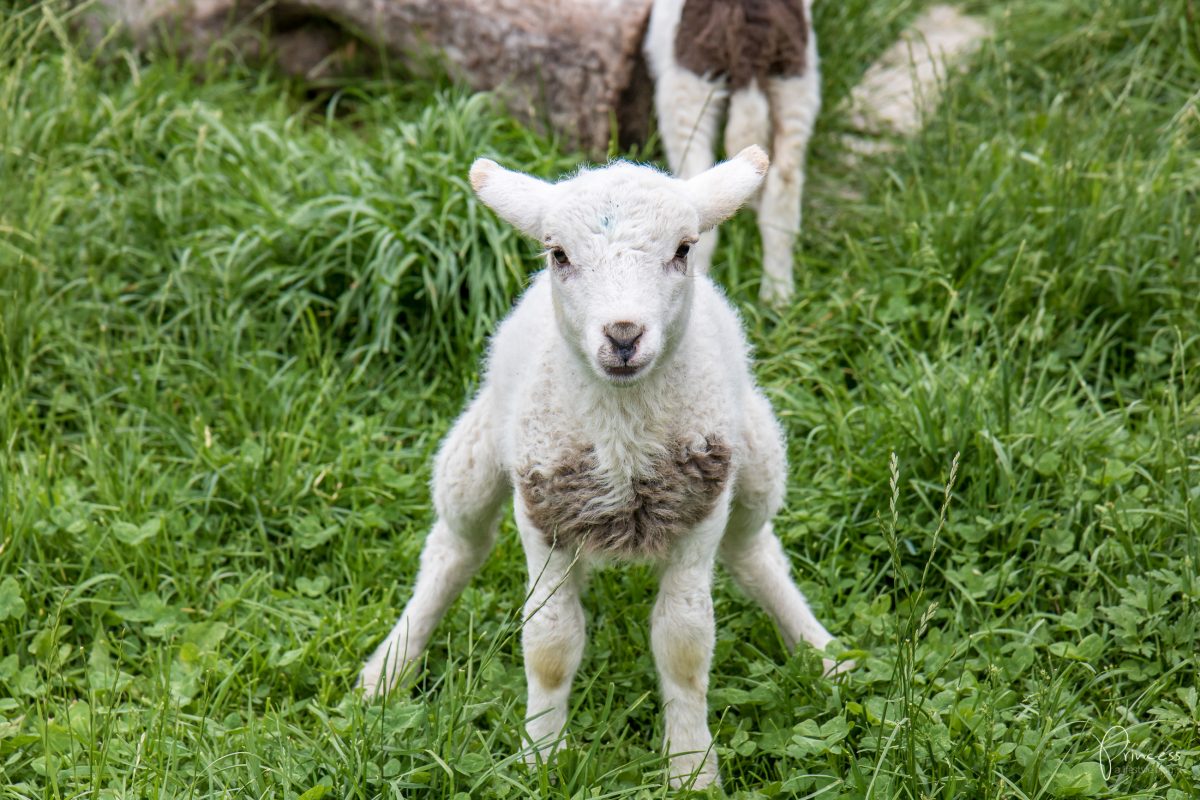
[720,392,853,674]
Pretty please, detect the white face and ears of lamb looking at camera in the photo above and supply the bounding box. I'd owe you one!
[470,148,767,385]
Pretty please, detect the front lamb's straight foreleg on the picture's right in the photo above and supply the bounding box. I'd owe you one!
[650,506,728,789]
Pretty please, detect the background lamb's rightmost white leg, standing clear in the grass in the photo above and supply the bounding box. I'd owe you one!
[758,68,821,306]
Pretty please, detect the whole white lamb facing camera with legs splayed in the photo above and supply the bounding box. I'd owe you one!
[359,148,844,786]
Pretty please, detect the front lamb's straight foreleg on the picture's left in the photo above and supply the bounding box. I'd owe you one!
[517,499,587,764]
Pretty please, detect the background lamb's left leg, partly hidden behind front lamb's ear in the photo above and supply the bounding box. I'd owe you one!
[654,65,726,275]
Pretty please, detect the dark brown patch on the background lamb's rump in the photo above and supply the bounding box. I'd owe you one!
[674,0,809,90]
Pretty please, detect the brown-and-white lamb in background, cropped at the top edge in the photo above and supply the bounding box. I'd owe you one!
[644,0,821,306]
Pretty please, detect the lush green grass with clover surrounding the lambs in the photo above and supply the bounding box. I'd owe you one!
[0,0,1200,800]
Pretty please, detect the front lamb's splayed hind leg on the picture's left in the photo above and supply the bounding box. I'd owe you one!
[358,389,509,697]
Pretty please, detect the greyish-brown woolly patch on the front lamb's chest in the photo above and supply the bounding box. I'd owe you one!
[517,437,732,558]
